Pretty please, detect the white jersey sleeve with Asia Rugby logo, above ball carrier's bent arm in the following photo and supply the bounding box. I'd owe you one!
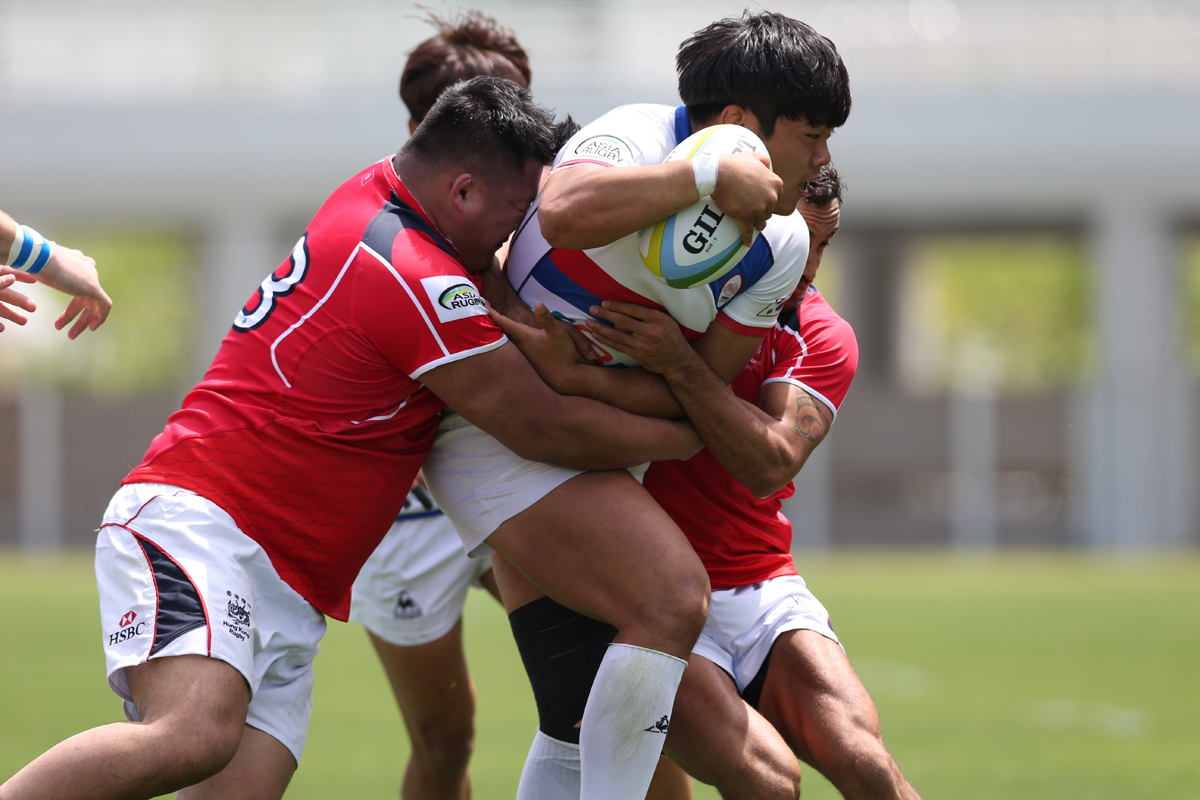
[554,106,676,170]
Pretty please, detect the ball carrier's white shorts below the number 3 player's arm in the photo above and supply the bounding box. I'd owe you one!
[421,410,582,558]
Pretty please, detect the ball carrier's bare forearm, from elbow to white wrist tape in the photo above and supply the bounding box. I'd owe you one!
[538,160,700,249]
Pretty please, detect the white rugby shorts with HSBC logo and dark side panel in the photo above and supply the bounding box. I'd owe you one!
[96,483,325,763]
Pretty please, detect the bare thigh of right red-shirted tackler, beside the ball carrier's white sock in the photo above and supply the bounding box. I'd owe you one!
[664,655,800,798]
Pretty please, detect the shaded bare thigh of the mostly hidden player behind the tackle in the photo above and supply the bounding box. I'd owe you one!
[370,620,475,738]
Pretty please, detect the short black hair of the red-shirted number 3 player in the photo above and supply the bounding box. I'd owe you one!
[400,77,580,180]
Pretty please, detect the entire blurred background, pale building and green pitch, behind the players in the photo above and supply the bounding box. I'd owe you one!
[0,0,1200,799]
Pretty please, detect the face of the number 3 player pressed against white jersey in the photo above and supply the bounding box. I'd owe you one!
[455,161,541,272]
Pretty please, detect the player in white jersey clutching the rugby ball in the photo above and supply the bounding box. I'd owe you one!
[426,13,850,800]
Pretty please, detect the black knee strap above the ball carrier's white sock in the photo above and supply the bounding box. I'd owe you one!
[509,597,617,745]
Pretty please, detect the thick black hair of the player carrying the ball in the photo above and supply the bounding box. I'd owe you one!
[676,11,851,137]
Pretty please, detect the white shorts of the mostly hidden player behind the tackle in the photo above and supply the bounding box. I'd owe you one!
[350,511,492,648]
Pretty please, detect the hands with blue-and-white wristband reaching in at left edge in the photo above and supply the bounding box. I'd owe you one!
[0,211,113,339]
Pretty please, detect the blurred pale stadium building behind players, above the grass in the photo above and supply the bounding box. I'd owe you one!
[0,0,1200,549]
